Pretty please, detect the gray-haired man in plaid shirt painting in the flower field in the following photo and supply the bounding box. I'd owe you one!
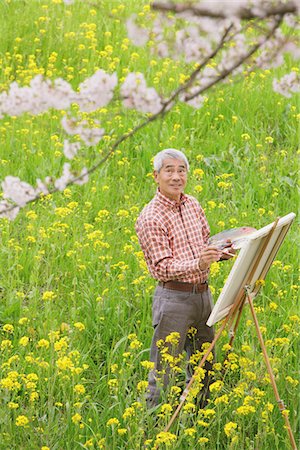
[136,149,232,406]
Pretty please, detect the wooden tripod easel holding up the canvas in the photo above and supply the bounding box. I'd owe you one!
[164,218,297,450]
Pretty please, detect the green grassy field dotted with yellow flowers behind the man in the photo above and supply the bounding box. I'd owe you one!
[0,0,300,450]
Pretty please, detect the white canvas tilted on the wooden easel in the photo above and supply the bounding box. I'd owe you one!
[207,213,296,326]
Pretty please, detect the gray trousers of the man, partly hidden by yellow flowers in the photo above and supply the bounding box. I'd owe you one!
[147,286,214,407]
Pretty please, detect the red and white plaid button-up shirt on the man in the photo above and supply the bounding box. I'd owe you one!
[135,190,210,284]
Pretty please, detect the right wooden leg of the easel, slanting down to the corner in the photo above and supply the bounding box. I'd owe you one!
[247,292,297,450]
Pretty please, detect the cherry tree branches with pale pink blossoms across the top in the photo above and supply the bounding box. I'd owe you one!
[0,0,300,219]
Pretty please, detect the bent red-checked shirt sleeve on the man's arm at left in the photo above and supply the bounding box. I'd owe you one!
[137,221,204,281]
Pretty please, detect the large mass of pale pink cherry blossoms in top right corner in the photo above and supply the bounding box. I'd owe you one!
[127,0,300,99]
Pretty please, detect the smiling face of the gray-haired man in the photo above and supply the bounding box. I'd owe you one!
[154,158,187,201]
